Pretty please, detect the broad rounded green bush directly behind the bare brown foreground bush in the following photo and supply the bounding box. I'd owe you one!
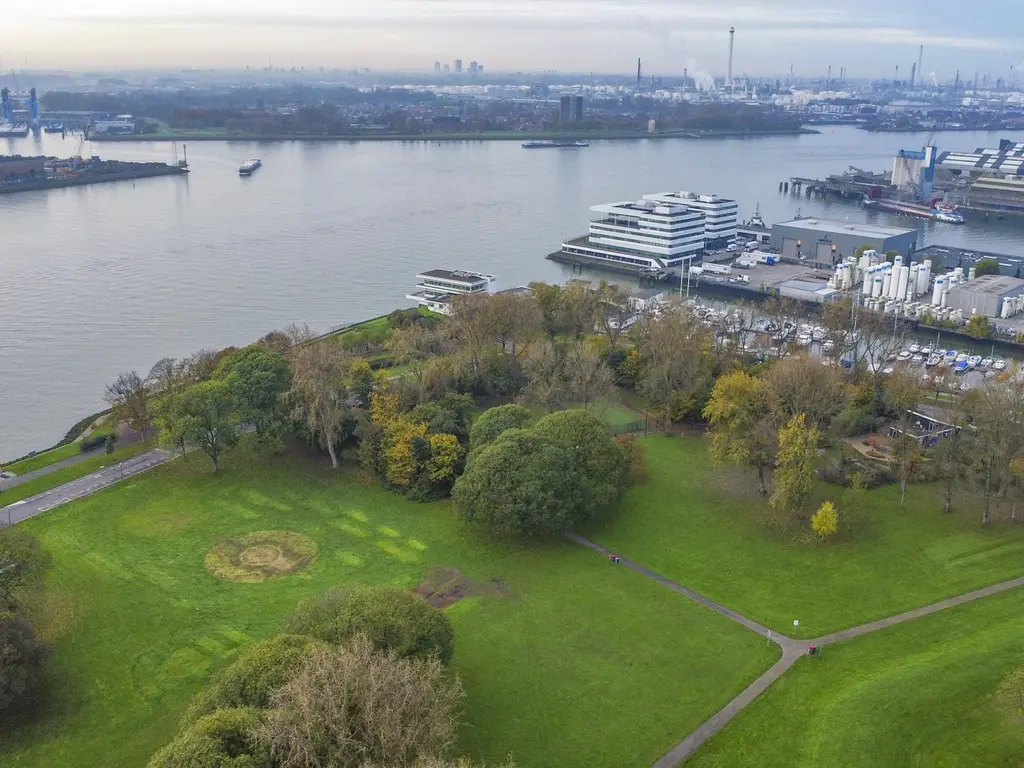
[288,587,455,664]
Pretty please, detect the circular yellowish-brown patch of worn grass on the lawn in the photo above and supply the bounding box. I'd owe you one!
[206,530,318,582]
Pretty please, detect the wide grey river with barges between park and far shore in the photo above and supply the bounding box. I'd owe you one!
[0,127,1024,459]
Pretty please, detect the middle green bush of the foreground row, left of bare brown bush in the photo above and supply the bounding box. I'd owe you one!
[184,635,321,723]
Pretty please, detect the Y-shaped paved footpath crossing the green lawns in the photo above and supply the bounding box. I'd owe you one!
[566,534,1024,768]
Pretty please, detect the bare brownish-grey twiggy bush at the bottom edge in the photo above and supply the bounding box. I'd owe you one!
[258,635,463,768]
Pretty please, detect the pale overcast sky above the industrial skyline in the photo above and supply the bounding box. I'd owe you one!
[0,0,1024,80]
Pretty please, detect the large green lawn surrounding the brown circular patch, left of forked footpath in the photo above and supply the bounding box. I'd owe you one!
[0,444,776,768]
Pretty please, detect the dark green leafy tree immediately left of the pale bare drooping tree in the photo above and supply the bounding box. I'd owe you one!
[215,345,292,438]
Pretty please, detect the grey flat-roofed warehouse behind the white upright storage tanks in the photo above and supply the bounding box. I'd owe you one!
[771,218,919,265]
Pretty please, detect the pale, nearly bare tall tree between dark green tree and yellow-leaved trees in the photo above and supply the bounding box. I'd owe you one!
[287,342,350,469]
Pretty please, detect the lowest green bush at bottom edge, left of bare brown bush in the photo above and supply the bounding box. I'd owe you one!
[148,709,271,768]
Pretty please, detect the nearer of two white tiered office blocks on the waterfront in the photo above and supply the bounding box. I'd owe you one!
[562,200,705,270]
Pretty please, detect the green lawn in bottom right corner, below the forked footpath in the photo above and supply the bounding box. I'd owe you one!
[686,590,1024,768]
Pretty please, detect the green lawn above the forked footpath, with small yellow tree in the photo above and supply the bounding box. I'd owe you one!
[586,437,1024,637]
